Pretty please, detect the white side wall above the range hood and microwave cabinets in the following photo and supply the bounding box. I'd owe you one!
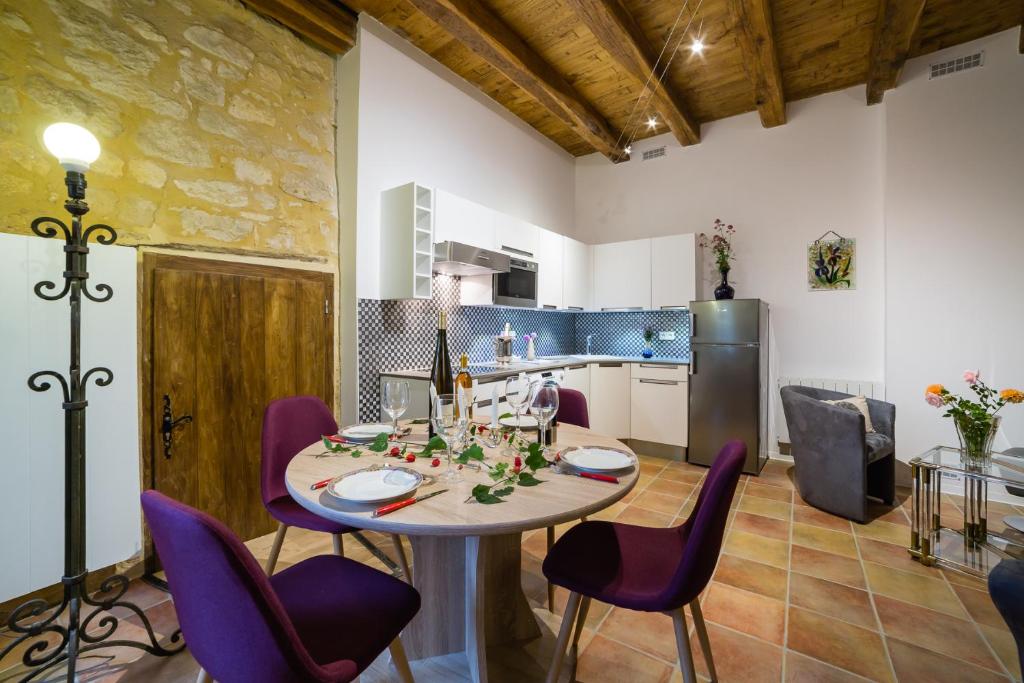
[350,19,574,298]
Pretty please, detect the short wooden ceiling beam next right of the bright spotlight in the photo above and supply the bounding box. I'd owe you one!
[729,0,785,128]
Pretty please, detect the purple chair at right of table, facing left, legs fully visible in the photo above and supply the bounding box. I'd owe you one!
[544,441,746,683]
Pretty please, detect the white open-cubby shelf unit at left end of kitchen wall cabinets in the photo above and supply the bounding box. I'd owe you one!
[380,182,434,299]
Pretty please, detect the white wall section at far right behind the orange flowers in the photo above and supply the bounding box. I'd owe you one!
[885,29,1024,464]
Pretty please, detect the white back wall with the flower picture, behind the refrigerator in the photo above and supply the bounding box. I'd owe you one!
[575,87,885,387]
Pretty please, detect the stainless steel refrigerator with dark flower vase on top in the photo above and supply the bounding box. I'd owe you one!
[686,299,770,474]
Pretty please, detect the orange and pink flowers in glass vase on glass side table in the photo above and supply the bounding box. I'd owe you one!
[925,370,1024,464]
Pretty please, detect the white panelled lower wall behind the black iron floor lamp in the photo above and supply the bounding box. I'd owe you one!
[0,233,141,601]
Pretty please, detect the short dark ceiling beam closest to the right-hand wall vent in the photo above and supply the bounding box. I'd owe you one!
[867,0,926,104]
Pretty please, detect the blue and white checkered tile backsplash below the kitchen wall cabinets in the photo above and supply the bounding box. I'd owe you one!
[357,275,690,421]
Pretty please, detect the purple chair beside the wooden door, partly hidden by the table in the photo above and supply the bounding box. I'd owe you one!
[260,396,413,584]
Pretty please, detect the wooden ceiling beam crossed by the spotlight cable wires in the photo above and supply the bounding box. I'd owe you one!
[565,0,700,145]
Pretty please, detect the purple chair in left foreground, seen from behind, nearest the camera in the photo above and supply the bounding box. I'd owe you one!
[142,490,420,683]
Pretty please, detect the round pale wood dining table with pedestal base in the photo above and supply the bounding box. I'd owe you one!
[286,425,640,682]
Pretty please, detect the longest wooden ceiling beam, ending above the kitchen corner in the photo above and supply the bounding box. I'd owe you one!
[397,0,624,162]
